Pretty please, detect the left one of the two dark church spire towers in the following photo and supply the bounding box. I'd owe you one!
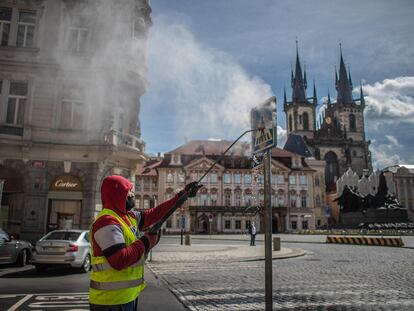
[283,41,318,138]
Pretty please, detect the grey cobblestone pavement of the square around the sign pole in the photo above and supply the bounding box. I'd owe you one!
[148,243,414,311]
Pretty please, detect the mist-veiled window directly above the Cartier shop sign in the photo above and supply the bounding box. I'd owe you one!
[60,99,85,130]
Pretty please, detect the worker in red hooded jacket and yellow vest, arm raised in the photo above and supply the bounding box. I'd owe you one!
[89,175,201,311]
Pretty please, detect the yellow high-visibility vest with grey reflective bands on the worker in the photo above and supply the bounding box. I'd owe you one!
[89,209,147,305]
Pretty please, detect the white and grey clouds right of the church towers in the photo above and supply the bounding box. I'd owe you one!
[362,76,414,169]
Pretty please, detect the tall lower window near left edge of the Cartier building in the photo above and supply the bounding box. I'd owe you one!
[6,81,27,125]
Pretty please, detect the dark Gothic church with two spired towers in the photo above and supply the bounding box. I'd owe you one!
[284,43,372,191]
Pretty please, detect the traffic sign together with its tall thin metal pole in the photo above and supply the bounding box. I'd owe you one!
[250,96,277,311]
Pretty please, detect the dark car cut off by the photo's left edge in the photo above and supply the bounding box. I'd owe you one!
[0,228,33,267]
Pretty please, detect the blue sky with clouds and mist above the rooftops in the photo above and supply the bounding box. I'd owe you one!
[140,0,414,169]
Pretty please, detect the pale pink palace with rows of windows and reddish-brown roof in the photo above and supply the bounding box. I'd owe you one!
[149,140,325,233]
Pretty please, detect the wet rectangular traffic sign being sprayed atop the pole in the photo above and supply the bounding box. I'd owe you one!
[250,96,277,155]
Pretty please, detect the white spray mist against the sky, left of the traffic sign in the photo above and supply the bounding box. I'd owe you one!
[146,16,274,145]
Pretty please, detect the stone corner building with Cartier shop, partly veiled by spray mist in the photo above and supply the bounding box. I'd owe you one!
[0,0,151,240]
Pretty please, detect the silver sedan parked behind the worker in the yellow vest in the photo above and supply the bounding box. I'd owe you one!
[31,230,91,273]
